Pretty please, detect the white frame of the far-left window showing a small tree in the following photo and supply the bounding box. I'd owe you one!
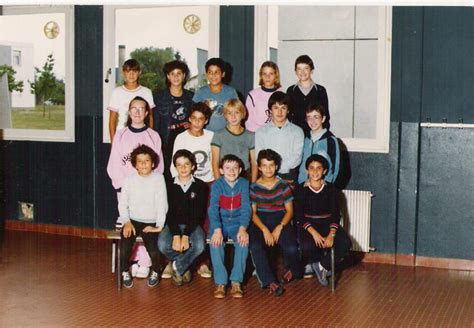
[0,5,75,142]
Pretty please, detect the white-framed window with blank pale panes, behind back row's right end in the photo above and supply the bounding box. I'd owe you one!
[255,6,392,152]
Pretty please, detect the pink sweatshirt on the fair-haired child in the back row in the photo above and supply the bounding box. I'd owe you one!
[245,86,283,132]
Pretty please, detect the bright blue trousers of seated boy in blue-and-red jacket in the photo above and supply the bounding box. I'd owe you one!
[209,225,249,285]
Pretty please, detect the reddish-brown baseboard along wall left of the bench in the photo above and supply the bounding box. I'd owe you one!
[5,220,107,238]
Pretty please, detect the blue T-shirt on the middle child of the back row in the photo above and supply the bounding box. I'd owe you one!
[193,84,239,132]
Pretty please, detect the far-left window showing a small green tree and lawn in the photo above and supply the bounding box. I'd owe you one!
[0,6,74,142]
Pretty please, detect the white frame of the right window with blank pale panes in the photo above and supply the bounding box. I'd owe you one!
[254,5,392,153]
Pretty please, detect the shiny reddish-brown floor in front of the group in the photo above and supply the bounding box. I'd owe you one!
[0,231,474,328]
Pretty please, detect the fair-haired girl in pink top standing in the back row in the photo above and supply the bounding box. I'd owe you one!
[245,61,283,132]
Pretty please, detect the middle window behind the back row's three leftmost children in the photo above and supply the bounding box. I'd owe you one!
[103,6,219,142]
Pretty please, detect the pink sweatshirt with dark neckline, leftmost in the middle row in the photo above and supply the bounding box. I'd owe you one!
[107,127,164,190]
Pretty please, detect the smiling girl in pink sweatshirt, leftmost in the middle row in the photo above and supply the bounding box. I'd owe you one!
[107,96,164,277]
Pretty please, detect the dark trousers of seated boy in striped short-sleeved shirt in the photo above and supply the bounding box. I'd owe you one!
[249,211,301,287]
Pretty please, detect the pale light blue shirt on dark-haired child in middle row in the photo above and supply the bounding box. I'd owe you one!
[255,120,304,174]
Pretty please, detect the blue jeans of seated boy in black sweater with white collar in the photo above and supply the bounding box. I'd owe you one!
[158,224,205,275]
